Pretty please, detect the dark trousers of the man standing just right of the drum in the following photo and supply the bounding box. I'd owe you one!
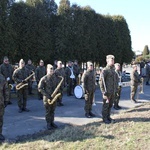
[84,92,94,114]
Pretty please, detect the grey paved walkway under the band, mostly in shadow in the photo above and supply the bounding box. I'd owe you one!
[3,83,150,140]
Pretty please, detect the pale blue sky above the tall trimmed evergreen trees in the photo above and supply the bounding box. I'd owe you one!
[16,0,150,51]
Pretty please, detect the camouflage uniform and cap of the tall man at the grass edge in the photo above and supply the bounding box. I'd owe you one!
[99,55,118,123]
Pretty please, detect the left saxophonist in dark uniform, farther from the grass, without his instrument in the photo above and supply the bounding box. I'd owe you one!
[12,59,29,113]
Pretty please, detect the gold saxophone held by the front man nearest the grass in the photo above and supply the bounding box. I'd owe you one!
[48,76,64,105]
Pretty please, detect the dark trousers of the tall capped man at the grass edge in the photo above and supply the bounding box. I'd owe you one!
[102,94,115,120]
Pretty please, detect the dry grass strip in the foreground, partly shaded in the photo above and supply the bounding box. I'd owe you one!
[0,103,150,150]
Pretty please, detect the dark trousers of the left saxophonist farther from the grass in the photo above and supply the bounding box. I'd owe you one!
[17,88,28,109]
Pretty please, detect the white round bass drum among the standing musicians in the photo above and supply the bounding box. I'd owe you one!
[74,85,84,99]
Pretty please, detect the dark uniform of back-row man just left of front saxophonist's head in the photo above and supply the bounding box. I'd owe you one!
[35,66,46,100]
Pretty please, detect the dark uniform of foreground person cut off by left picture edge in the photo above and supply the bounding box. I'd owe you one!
[0,74,9,141]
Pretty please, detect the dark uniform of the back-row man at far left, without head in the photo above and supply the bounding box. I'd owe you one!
[0,63,14,104]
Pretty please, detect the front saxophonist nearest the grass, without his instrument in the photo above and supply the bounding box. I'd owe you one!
[38,64,58,130]
